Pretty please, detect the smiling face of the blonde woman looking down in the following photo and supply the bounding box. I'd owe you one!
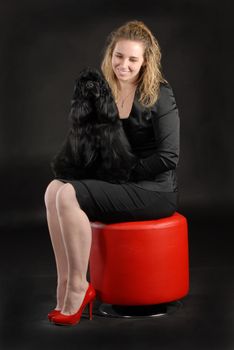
[112,39,144,83]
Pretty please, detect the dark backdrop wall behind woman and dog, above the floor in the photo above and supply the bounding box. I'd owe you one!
[0,0,234,223]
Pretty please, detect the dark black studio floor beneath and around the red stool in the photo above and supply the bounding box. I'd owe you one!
[0,209,234,350]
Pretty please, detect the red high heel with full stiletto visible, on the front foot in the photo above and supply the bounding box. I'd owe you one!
[52,283,96,326]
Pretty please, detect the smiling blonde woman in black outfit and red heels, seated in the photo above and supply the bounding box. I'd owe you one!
[45,21,179,325]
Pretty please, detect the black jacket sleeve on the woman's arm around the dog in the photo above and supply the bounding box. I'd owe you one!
[131,84,180,181]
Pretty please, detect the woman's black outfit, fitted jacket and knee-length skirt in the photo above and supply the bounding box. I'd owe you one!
[56,84,179,223]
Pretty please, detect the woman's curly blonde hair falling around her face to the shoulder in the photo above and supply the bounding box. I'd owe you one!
[101,20,166,107]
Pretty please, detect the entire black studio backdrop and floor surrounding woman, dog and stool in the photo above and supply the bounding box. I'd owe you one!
[0,0,234,350]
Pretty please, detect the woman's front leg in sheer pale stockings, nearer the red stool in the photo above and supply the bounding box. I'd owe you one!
[56,183,92,315]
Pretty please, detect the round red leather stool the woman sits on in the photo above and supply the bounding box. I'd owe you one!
[90,213,189,318]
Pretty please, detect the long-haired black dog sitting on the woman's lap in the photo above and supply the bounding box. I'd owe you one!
[52,68,136,183]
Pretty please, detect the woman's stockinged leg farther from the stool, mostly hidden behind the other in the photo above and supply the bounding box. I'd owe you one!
[45,180,68,310]
